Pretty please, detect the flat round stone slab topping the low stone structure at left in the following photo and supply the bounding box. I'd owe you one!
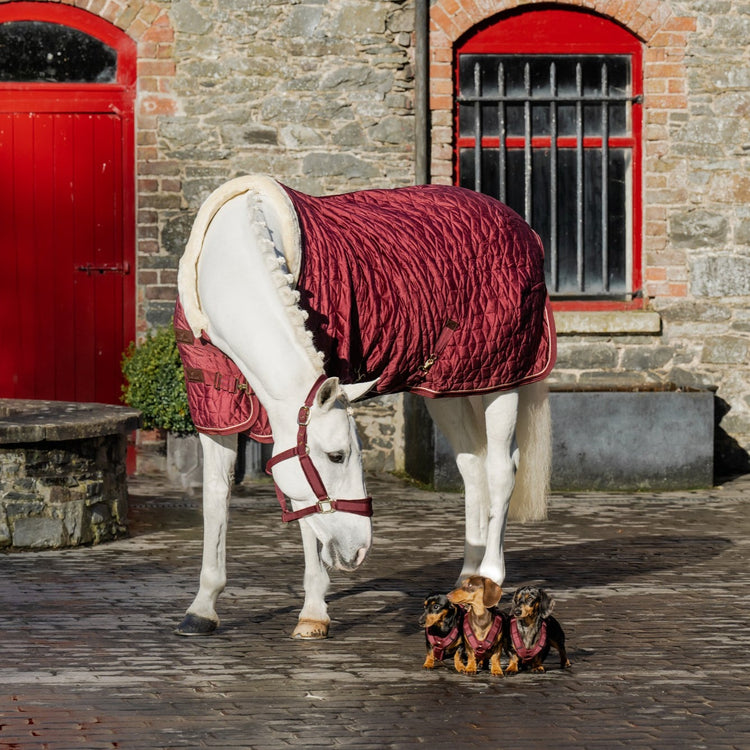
[0,399,141,444]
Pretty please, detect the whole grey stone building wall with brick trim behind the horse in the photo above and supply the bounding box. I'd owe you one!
[26,0,750,471]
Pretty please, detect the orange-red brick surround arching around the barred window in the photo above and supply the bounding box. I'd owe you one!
[430,0,696,297]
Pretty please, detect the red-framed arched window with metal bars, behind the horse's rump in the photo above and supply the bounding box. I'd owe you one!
[456,9,642,304]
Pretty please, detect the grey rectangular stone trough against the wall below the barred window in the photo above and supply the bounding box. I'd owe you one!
[418,380,716,492]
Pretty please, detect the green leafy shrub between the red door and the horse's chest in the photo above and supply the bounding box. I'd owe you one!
[122,326,195,435]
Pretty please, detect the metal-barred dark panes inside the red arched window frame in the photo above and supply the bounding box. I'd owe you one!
[458,54,639,299]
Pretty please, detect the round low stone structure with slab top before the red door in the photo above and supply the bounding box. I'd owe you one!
[0,399,140,549]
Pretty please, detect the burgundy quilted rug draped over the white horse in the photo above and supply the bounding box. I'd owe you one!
[175,185,555,441]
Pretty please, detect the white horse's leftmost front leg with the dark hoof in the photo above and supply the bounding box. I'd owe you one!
[175,434,237,635]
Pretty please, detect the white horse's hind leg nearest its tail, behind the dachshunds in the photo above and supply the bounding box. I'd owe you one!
[479,391,518,584]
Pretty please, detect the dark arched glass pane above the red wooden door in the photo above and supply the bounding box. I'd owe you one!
[0,21,117,83]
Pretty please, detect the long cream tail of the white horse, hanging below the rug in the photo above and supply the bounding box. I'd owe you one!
[508,381,552,521]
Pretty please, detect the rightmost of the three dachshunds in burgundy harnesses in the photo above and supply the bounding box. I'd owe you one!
[505,586,570,674]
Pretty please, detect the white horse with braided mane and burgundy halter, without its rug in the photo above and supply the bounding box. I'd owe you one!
[176,176,550,638]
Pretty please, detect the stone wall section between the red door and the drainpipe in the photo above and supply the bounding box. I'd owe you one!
[138,0,414,470]
